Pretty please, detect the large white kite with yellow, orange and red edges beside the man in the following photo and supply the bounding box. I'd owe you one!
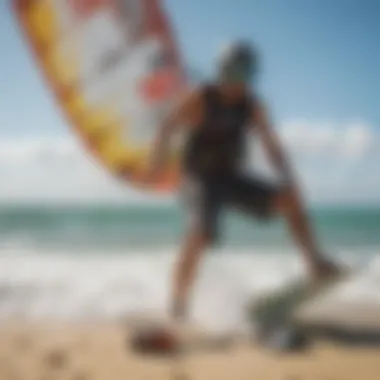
[11,0,187,192]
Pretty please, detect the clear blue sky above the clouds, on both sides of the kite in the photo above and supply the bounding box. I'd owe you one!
[0,0,380,203]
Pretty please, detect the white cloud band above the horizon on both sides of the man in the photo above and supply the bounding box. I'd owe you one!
[0,122,380,202]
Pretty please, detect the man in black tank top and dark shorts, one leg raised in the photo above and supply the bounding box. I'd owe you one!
[145,42,337,326]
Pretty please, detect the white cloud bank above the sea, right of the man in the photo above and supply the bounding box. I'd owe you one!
[280,122,380,202]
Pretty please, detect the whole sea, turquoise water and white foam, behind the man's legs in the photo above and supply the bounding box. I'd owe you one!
[0,204,380,329]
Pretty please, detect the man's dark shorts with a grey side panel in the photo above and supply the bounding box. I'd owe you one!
[181,175,281,242]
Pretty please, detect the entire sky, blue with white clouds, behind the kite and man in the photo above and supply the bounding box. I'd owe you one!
[0,0,380,204]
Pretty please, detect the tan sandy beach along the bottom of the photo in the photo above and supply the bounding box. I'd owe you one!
[0,322,380,380]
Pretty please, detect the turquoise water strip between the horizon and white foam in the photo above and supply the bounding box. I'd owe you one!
[0,205,380,251]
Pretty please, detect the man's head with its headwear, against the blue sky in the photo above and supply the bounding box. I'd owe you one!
[217,41,257,90]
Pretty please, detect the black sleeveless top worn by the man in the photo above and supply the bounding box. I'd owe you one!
[183,85,252,177]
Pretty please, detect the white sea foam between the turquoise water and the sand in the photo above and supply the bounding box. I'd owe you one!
[0,247,380,330]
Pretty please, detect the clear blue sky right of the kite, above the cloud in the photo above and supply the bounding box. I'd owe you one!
[167,0,380,125]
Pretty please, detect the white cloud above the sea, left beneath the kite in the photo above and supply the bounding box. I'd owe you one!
[0,135,171,202]
